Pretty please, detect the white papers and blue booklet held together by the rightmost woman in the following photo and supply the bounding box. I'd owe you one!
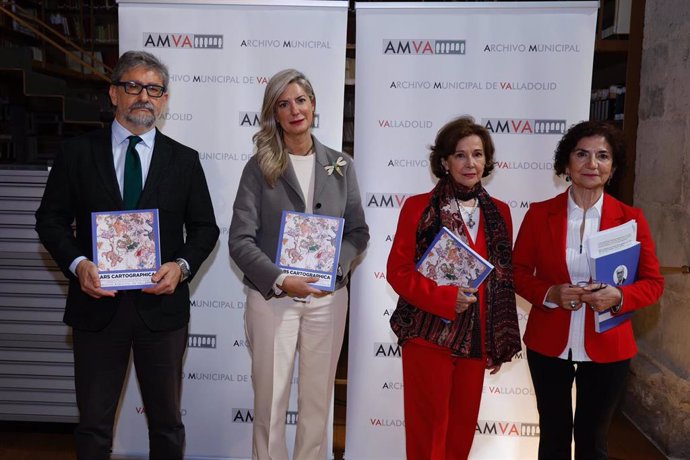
[586,220,640,333]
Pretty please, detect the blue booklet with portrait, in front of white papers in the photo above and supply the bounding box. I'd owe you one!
[590,242,640,332]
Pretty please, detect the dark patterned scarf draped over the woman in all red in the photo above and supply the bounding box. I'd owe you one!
[390,176,521,366]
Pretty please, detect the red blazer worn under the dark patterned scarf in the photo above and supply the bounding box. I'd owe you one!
[386,192,513,320]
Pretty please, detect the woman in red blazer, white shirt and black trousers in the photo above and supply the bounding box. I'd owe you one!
[513,121,664,460]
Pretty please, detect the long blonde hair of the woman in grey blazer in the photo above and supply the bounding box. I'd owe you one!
[252,69,315,187]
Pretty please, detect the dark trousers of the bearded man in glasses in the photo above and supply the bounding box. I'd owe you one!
[72,291,187,460]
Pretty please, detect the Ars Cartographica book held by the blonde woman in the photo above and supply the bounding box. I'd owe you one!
[276,211,345,291]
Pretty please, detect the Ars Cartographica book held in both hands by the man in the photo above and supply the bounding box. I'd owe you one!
[91,209,161,290]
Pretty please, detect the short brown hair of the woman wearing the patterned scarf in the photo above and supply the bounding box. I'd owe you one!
[429,116,495,179]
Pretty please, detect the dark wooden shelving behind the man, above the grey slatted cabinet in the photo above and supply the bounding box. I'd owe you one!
[0,0,118,167]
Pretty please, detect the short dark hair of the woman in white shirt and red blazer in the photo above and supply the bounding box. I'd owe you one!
[553,120,625,176]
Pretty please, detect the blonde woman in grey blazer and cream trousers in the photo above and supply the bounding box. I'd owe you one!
[229,69,369,460]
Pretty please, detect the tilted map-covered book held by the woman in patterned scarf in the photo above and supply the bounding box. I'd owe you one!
[417,227,494,288]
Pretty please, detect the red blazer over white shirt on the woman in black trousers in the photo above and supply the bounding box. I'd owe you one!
[513,192,664,363]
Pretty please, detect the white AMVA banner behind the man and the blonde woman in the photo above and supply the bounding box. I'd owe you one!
[114,0,347,459]
